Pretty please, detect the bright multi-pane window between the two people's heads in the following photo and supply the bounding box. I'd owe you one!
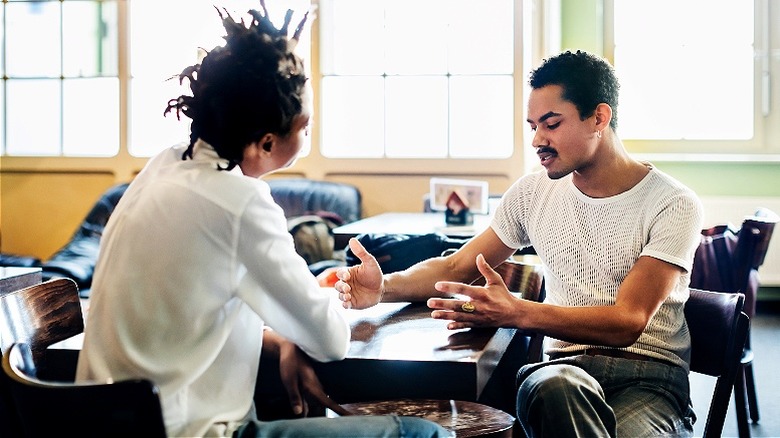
[319,0,515,158]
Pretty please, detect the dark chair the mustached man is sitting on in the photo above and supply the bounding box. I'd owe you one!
[685,289,750,438]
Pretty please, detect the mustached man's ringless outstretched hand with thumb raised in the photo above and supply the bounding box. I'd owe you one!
[334,238,384,309]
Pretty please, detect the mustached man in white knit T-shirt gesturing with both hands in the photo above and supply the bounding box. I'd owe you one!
[336,51,702,437]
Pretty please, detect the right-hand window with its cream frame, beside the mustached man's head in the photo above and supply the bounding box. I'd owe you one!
[606,0,780,154]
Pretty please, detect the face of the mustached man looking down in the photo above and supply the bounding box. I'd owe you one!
[528,85,598,179]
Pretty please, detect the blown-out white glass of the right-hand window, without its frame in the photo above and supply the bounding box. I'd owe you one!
[614,0,754,140]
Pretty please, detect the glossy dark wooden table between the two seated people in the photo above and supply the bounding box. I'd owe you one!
[46,292,529,419]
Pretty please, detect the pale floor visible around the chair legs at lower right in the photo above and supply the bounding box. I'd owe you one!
[691,301,780,437]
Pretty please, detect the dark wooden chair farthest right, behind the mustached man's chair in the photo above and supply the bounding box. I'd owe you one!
[691,208,779,436]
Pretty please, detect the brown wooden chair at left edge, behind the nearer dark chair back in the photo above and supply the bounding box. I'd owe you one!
[0,278,84,436]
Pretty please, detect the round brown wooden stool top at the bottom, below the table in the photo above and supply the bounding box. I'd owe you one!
[332,399,515,438]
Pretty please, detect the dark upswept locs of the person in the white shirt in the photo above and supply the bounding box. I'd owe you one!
[164,0,308,170]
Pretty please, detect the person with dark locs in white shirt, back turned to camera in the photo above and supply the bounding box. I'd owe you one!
[77,2,448,437]
